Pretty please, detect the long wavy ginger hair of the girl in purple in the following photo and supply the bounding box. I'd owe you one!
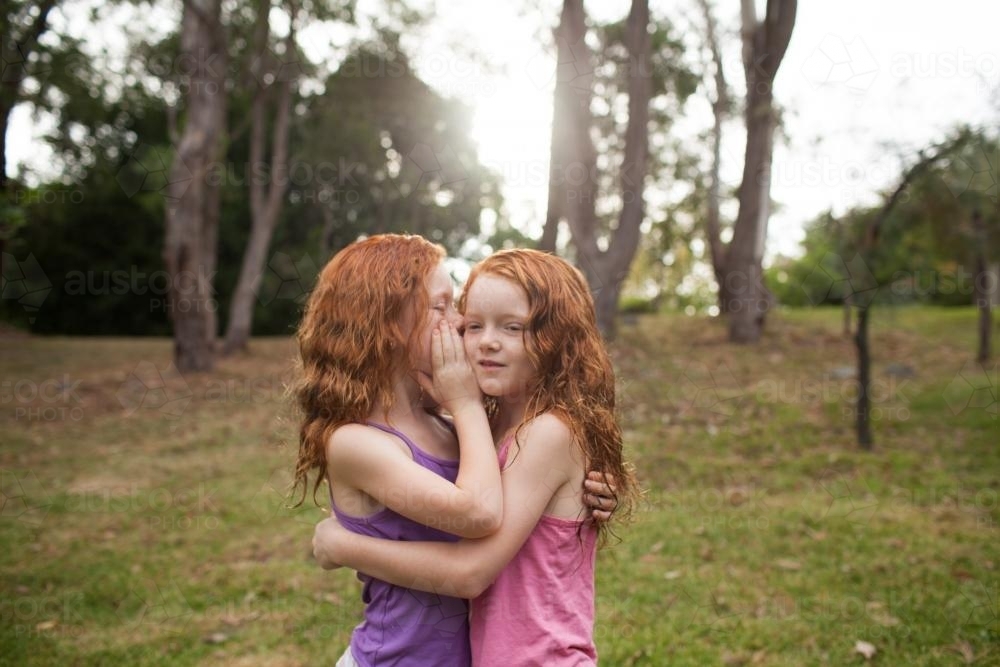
[294,234,445,505]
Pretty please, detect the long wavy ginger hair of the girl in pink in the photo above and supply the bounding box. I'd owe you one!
[458,249,640,533]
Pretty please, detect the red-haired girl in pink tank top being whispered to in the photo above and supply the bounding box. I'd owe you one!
[313,250,638,667]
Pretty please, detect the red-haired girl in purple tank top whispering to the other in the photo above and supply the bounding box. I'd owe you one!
[296,234,616,667]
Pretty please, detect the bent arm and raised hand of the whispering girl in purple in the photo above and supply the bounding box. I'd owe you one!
[326,325,503,537]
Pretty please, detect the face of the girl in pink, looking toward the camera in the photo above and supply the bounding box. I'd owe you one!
[464,273,537,399]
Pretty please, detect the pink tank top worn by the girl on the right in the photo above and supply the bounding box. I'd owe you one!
[469,438,597,667]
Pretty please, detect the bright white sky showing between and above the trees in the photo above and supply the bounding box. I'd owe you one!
[8,0,1000,256]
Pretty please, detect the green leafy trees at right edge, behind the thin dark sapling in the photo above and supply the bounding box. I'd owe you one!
[767,129,1000,306]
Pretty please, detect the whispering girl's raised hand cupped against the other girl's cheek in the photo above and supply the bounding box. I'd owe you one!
[417,321,482,414]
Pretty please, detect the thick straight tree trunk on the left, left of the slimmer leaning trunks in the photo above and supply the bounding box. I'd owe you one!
[163,0,227,372]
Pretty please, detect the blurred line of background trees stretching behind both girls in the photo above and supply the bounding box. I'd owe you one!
[0,0,1000,400]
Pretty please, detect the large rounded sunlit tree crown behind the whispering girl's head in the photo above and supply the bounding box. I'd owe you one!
[292,40,500,253]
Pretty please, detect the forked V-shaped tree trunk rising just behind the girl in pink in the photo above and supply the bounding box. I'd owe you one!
[553,0,652,338]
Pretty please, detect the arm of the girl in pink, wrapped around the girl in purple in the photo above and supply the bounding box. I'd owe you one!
[313,415,580,598]
